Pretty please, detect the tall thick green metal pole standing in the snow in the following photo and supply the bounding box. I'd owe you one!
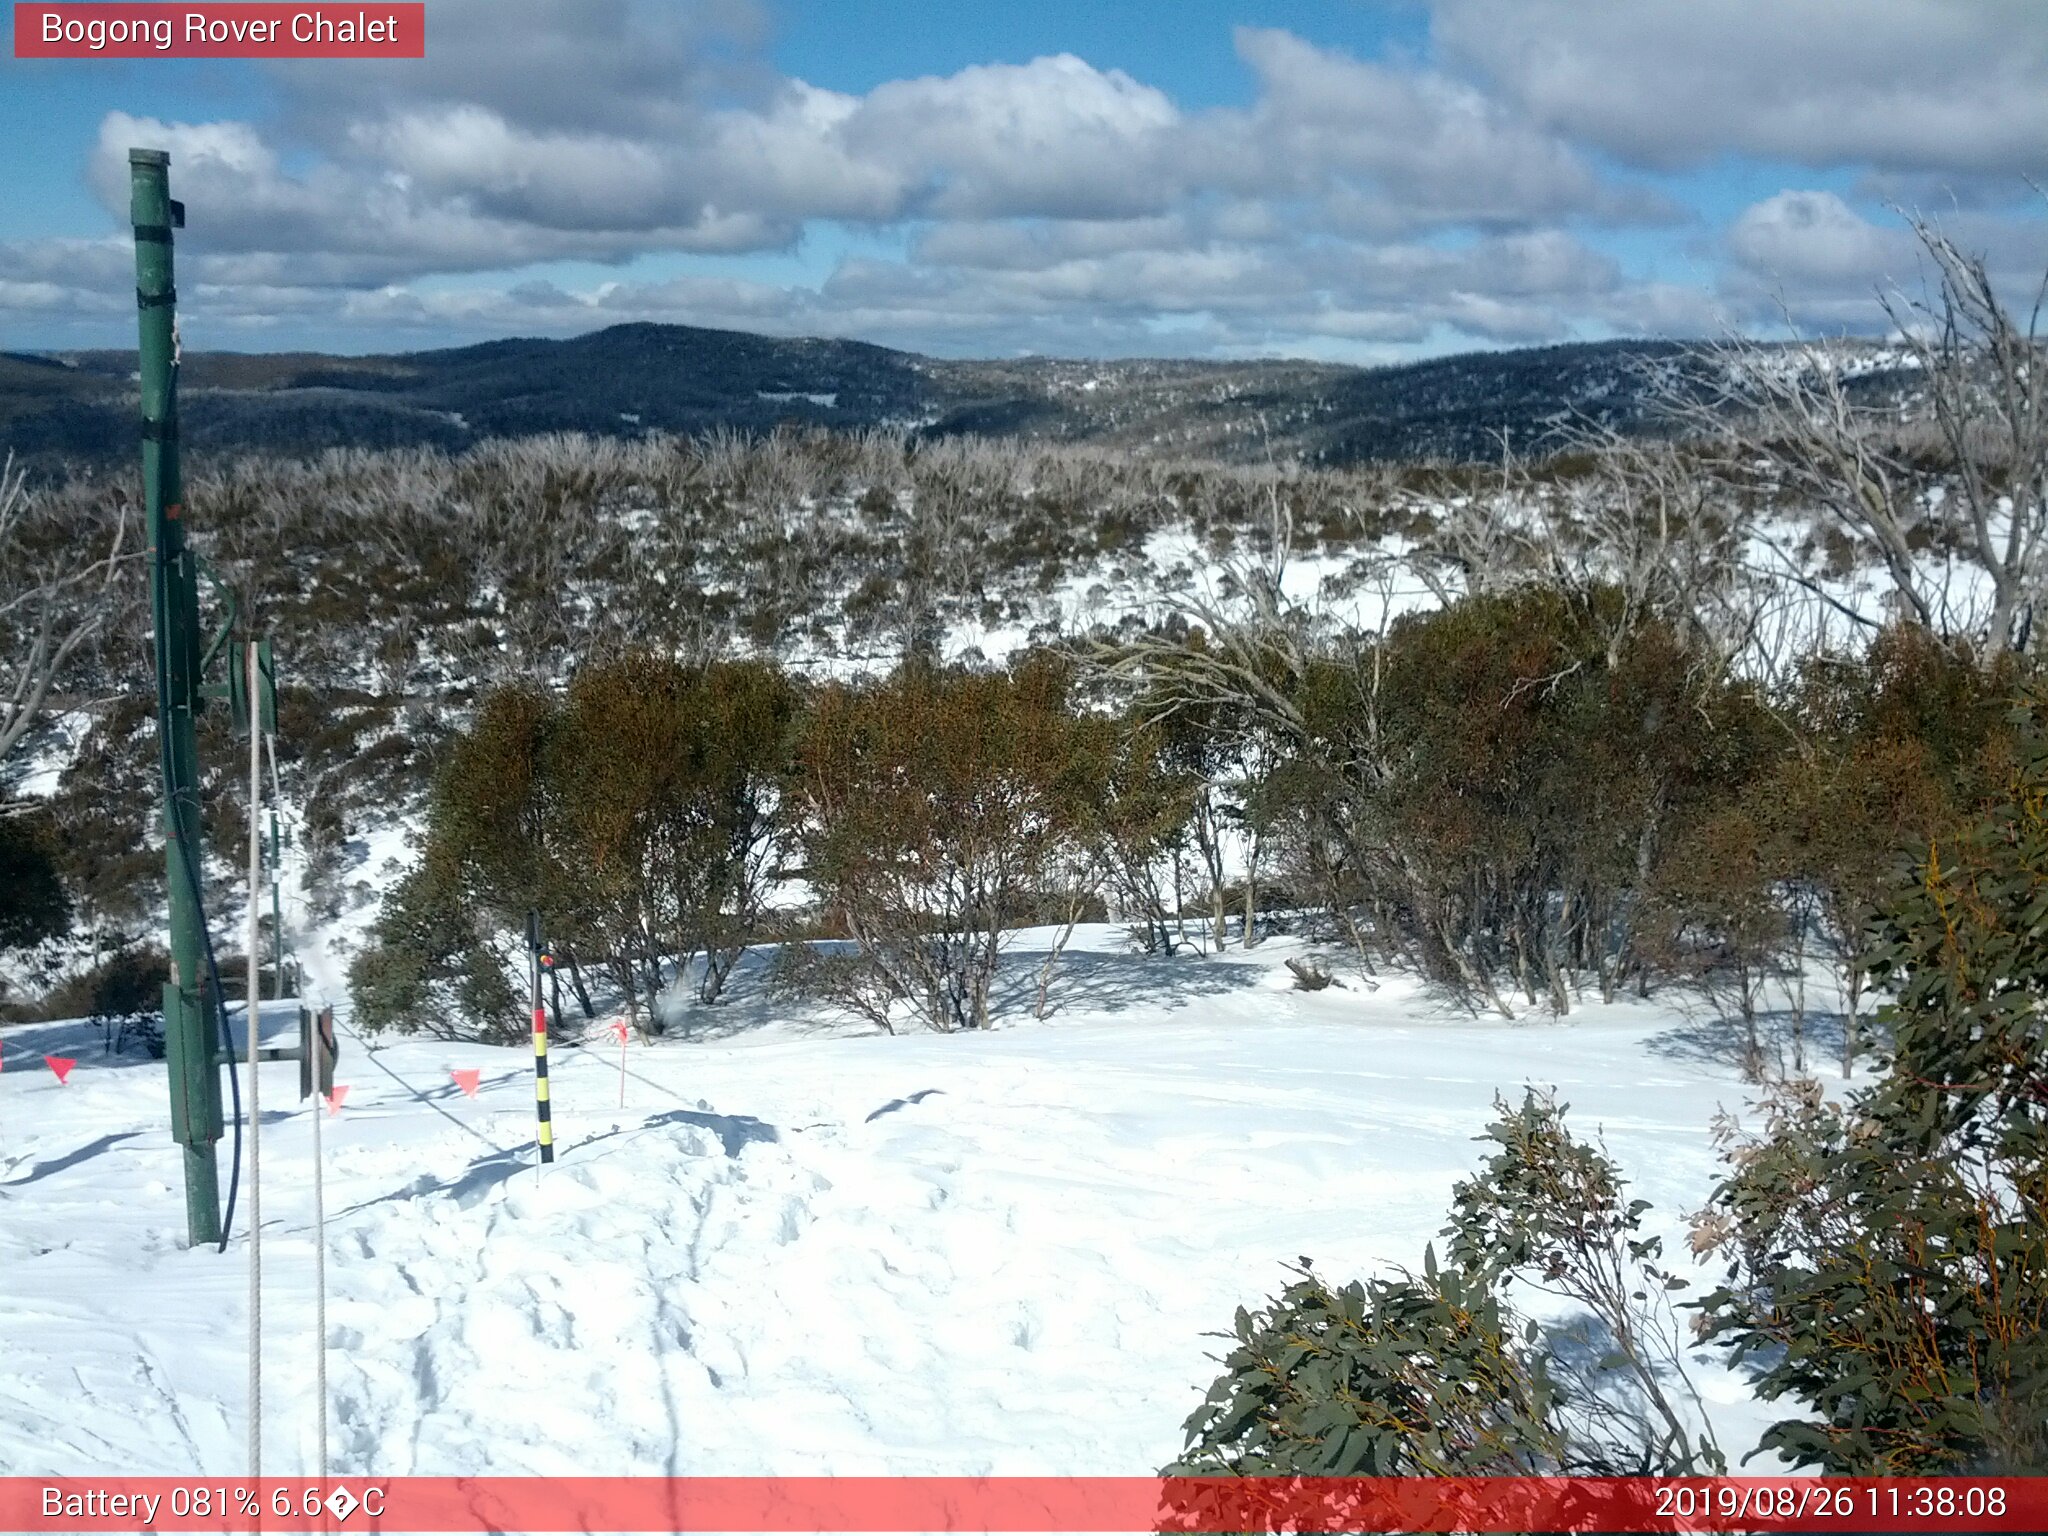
[129,150,221,1247]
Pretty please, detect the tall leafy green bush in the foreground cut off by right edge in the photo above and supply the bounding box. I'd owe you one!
[1694,696,2048,1475]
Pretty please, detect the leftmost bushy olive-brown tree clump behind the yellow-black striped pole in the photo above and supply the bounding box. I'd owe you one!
[350,653,801,1038]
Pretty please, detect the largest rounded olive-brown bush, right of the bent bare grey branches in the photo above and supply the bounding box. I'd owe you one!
[1268,586,1765,1014]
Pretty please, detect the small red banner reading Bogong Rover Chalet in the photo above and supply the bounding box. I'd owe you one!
[14,0,426,59]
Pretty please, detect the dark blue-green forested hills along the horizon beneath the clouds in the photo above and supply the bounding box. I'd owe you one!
[0,324,1686,465]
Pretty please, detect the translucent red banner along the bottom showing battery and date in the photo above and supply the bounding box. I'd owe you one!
[0,1477,2048,1532]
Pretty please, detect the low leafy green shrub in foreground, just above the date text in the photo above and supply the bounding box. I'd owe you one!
[1167,1094,1724,1477]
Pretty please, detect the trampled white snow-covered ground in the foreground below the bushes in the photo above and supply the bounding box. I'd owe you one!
[0,928,1810,1475]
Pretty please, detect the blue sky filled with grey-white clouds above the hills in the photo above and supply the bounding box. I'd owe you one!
[0,0,2048,362]
